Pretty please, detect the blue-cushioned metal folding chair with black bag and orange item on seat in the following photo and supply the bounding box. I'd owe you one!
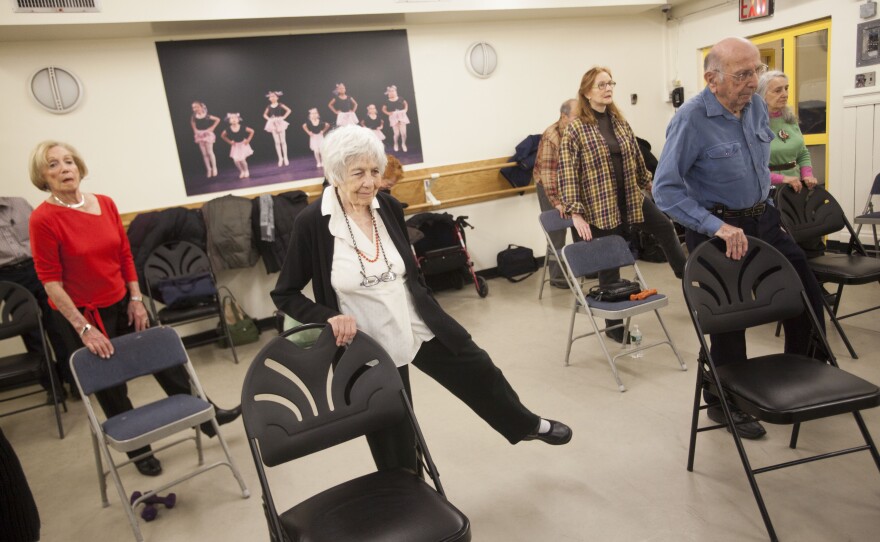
[562,235,687,391]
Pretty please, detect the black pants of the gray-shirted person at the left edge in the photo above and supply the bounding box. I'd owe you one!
[0,260,73,390]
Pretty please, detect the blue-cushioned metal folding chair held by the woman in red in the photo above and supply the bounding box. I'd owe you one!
[71,327,250,542]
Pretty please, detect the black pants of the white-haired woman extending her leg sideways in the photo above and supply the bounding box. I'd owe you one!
[367,338,540,470]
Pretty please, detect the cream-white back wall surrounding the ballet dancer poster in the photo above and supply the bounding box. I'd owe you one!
[0,13,671,317]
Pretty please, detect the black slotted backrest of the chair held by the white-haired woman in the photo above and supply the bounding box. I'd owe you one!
[241,324,406,467]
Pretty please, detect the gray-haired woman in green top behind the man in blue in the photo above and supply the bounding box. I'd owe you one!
[757,70,818,192]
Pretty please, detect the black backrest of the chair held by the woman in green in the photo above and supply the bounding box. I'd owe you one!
[776,186,847,242]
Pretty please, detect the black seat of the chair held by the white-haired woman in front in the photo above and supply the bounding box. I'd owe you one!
[280,469,470,542]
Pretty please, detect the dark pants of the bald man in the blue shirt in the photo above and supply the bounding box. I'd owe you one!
[685,205,825,404]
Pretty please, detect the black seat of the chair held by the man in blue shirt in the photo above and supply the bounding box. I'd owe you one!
[718,354,880,424]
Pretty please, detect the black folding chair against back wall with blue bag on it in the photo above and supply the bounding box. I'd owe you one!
[144,241,238,363]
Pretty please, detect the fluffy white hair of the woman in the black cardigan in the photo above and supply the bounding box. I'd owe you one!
[321,124,388,186]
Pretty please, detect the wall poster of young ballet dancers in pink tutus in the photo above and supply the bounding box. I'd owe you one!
[156,30,423,196]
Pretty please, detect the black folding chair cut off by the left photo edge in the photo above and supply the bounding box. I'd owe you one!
[0,281,67,438]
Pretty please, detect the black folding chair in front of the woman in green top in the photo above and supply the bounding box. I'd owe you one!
[776,186,880,359]
